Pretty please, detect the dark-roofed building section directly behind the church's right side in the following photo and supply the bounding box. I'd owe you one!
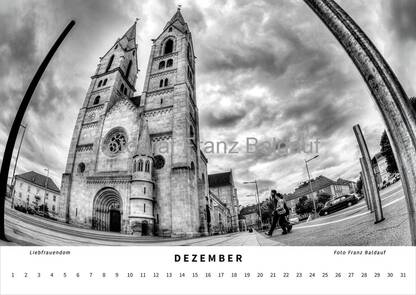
[208,170,239,232]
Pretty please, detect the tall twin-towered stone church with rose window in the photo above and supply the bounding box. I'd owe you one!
[60,9,209,237]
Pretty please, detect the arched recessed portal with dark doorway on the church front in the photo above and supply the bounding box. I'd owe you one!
[92,188,123,232]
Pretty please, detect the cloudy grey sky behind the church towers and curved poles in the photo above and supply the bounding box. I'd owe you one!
[0,0,416,204]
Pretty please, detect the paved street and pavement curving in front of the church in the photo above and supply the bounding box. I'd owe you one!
[2,182,410,246]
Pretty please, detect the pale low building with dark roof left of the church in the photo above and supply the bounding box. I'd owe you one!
[13,171,61,217]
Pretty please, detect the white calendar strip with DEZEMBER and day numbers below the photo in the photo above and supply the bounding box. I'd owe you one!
[0,246,416,295]
